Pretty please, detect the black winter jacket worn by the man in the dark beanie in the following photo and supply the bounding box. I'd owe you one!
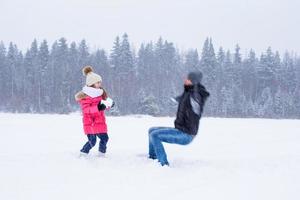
[175,84,209,136]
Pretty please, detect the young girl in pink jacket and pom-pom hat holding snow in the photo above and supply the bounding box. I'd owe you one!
[75,66,114,156]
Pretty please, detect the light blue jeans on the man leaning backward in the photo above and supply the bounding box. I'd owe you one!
[149,127,193,166]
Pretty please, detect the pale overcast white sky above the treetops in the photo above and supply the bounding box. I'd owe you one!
[0,0,300,53]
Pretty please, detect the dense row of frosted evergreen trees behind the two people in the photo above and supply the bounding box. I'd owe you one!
[0,34,300,118]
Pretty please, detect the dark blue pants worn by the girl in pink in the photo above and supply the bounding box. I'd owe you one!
[80,133,109,153]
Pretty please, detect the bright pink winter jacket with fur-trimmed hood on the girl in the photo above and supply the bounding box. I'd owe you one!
[75,92,107,135]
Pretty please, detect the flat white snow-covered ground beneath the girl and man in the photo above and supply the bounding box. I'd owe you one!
[0,114,300,200]
